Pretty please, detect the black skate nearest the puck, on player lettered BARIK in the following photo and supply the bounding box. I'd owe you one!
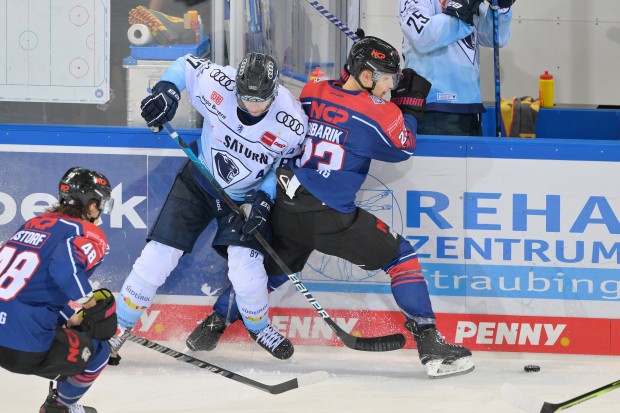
[405,320,475,379]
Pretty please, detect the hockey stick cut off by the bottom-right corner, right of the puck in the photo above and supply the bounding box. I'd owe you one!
[501,380,620,413]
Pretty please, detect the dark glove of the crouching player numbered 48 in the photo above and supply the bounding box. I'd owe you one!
[76,288,116,340]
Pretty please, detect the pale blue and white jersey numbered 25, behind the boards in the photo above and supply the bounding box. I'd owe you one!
[398,0,512,113]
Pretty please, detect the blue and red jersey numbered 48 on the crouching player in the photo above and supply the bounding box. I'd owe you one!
[0,213,108,352]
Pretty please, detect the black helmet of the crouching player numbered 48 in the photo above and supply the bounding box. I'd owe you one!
[58,166,114,214]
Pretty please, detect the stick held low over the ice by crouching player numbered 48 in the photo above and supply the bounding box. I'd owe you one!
[124,333,329,394]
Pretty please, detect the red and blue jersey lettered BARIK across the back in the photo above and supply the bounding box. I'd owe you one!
[291,80,417,213]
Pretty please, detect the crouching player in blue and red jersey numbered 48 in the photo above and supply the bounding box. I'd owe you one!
[0,167,116,413]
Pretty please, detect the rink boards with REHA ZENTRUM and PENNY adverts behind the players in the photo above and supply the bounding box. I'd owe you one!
[0,125,620,354]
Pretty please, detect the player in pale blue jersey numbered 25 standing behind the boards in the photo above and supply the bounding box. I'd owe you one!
[398,0,516,136]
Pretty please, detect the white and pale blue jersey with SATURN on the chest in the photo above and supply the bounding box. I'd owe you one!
[162,55,308,201]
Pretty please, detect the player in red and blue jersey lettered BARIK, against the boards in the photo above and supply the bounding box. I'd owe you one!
[187,37,474,377]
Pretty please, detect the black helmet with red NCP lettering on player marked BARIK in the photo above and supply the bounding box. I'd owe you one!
[347,36,400,91]
